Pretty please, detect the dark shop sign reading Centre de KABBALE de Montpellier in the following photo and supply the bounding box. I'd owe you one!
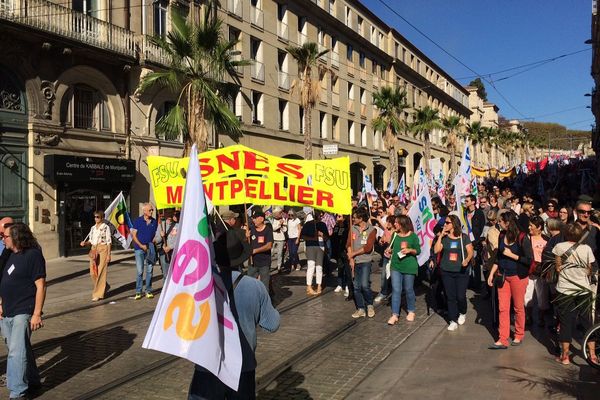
[44,154,135,183]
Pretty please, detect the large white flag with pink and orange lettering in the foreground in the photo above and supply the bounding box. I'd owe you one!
[143,145,242,390]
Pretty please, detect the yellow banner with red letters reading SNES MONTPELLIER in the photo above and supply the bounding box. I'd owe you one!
[147,145,352,214]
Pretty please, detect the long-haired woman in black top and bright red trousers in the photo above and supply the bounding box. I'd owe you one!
[488,212,533,350]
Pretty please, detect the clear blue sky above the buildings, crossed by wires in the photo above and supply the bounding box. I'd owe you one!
[362,0,594,130]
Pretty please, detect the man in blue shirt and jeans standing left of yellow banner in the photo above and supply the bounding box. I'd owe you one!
[131,203,158,300]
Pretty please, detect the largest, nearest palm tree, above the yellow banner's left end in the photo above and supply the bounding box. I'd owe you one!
[138,7,249,155]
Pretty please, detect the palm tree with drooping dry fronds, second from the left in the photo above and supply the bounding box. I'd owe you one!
[285,42,329,160]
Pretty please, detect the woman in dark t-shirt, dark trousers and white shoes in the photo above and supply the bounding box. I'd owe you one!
[433,214,474,331]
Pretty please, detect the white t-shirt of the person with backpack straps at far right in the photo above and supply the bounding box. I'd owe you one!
[552,242,596,294]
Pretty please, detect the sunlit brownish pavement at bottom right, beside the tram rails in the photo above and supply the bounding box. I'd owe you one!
[348,293,600,400]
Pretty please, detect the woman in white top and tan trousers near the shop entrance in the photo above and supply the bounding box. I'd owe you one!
[80,211,112,301]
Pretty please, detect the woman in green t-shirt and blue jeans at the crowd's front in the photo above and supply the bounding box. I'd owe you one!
[385,215,421,325]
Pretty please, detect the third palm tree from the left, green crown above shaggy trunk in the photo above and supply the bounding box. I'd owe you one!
[371,86,408,184]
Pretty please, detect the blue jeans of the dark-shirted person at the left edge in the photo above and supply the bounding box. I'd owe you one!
[0,314,40,397]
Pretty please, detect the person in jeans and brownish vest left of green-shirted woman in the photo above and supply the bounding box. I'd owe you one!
[346,208,376,318]
